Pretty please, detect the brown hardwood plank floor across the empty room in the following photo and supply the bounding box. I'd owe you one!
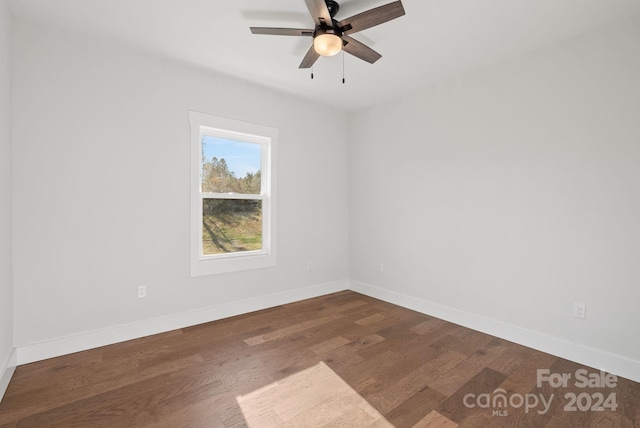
[0,291,640,428]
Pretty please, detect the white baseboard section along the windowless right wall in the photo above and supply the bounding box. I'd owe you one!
[349,281,640,382]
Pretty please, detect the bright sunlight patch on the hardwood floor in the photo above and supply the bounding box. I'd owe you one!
[236,362,393,428]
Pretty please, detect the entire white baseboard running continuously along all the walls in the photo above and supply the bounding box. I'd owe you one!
[11,281,640,386]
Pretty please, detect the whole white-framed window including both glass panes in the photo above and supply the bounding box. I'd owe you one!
[189,111,278,276]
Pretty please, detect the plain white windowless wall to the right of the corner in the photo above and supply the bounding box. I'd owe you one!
[349,16,640,378]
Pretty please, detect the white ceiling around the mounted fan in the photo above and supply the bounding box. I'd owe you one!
[8,0,640,110]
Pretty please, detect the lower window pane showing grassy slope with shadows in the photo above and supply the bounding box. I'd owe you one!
[202,199,262,256]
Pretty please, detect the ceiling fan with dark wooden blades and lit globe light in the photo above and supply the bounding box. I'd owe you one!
[250,0,405,68]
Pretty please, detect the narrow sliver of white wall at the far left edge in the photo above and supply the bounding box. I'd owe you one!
[0,0,15,398]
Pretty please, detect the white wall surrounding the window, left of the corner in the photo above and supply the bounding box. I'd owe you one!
[13,20,348,352]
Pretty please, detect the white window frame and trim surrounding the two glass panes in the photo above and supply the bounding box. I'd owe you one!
[189,111,278,277]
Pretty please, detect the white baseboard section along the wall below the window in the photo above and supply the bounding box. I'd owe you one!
[17,280,348,365]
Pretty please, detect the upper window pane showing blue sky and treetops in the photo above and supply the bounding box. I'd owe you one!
[200,135,261,195]
